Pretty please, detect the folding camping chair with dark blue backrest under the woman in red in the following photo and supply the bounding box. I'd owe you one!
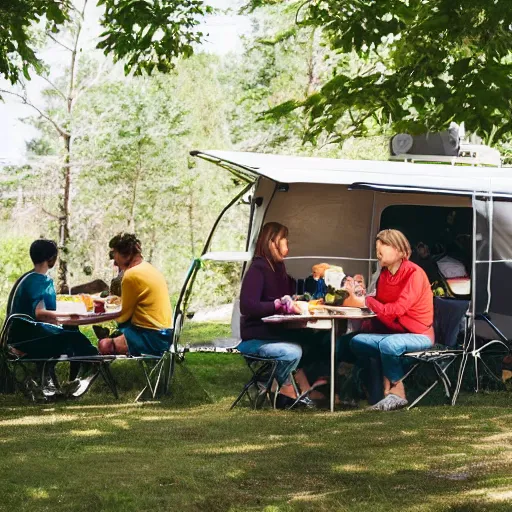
[402,297,469,409]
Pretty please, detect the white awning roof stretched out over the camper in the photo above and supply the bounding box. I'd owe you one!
[190,150,512,197]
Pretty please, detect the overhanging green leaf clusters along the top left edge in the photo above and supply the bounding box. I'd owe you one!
[0,0,212,83]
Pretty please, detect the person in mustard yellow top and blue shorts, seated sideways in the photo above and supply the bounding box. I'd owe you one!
[98,233,172,356]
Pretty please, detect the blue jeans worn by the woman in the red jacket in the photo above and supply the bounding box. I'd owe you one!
[350,333,432,382]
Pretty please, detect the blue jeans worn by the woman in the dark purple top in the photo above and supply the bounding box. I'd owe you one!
[236,340,302,386]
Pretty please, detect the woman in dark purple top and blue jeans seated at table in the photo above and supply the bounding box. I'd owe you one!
[237,222,318,407]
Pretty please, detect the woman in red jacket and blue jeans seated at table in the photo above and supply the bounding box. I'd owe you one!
[350,229,434,411]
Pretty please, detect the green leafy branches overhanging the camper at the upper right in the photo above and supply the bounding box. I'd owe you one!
[257,0,512,142]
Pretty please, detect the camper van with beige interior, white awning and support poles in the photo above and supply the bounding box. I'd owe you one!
[175,147,512,376]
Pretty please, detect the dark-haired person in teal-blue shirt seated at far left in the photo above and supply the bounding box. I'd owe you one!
[7,239,98,396]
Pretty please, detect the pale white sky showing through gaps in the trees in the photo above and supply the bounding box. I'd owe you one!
[0,0,250,164]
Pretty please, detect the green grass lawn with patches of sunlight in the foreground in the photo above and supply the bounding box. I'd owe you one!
[0,324,512,512]
